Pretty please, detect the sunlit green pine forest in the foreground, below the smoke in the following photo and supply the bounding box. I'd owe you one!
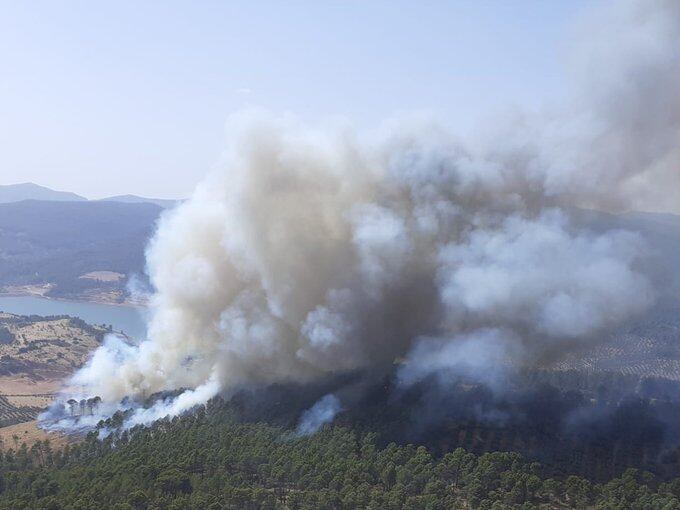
[0,401,680,510]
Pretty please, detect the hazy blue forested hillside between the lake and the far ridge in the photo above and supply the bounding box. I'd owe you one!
[0,200,162,297]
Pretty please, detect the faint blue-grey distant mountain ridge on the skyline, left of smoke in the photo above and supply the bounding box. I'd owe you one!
[0,182,182,209]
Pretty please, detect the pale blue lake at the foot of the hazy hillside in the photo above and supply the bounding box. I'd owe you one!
[0,296,146,339]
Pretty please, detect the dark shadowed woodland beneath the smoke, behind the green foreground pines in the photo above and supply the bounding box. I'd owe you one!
[330,371,680,483]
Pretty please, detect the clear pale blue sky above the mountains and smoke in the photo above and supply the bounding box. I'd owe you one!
[0,0,592,198]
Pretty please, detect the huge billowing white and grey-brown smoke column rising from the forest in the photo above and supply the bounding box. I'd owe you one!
[45,0,680,432]
